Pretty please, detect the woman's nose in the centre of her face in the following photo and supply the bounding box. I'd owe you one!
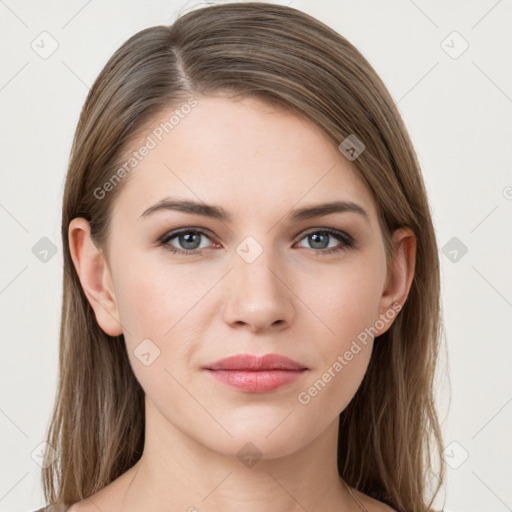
[222,244,295,332]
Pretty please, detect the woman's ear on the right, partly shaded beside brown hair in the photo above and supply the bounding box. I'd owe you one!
[376,228,416,337]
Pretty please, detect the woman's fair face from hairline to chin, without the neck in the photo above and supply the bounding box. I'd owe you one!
[78,97,410,458]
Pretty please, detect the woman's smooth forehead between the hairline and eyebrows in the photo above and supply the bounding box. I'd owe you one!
[114,96,376,224]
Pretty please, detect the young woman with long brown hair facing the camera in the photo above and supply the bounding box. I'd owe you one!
[36,3,445,512]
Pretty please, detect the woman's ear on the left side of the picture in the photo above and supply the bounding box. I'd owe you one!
[68,217,123,336]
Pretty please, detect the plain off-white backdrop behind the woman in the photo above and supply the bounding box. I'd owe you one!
[0,0,512,512]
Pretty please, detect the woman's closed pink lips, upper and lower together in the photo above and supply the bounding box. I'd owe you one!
[205,354,308,393]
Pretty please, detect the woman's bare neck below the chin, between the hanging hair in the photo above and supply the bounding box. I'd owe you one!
[120,398,360,512]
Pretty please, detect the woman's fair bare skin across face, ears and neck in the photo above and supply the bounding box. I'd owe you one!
[69,95,416,512]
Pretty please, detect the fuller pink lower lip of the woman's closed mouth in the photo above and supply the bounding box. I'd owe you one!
[207,370,307,393]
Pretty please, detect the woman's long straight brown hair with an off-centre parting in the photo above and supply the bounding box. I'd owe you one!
[42,2,445,512]
